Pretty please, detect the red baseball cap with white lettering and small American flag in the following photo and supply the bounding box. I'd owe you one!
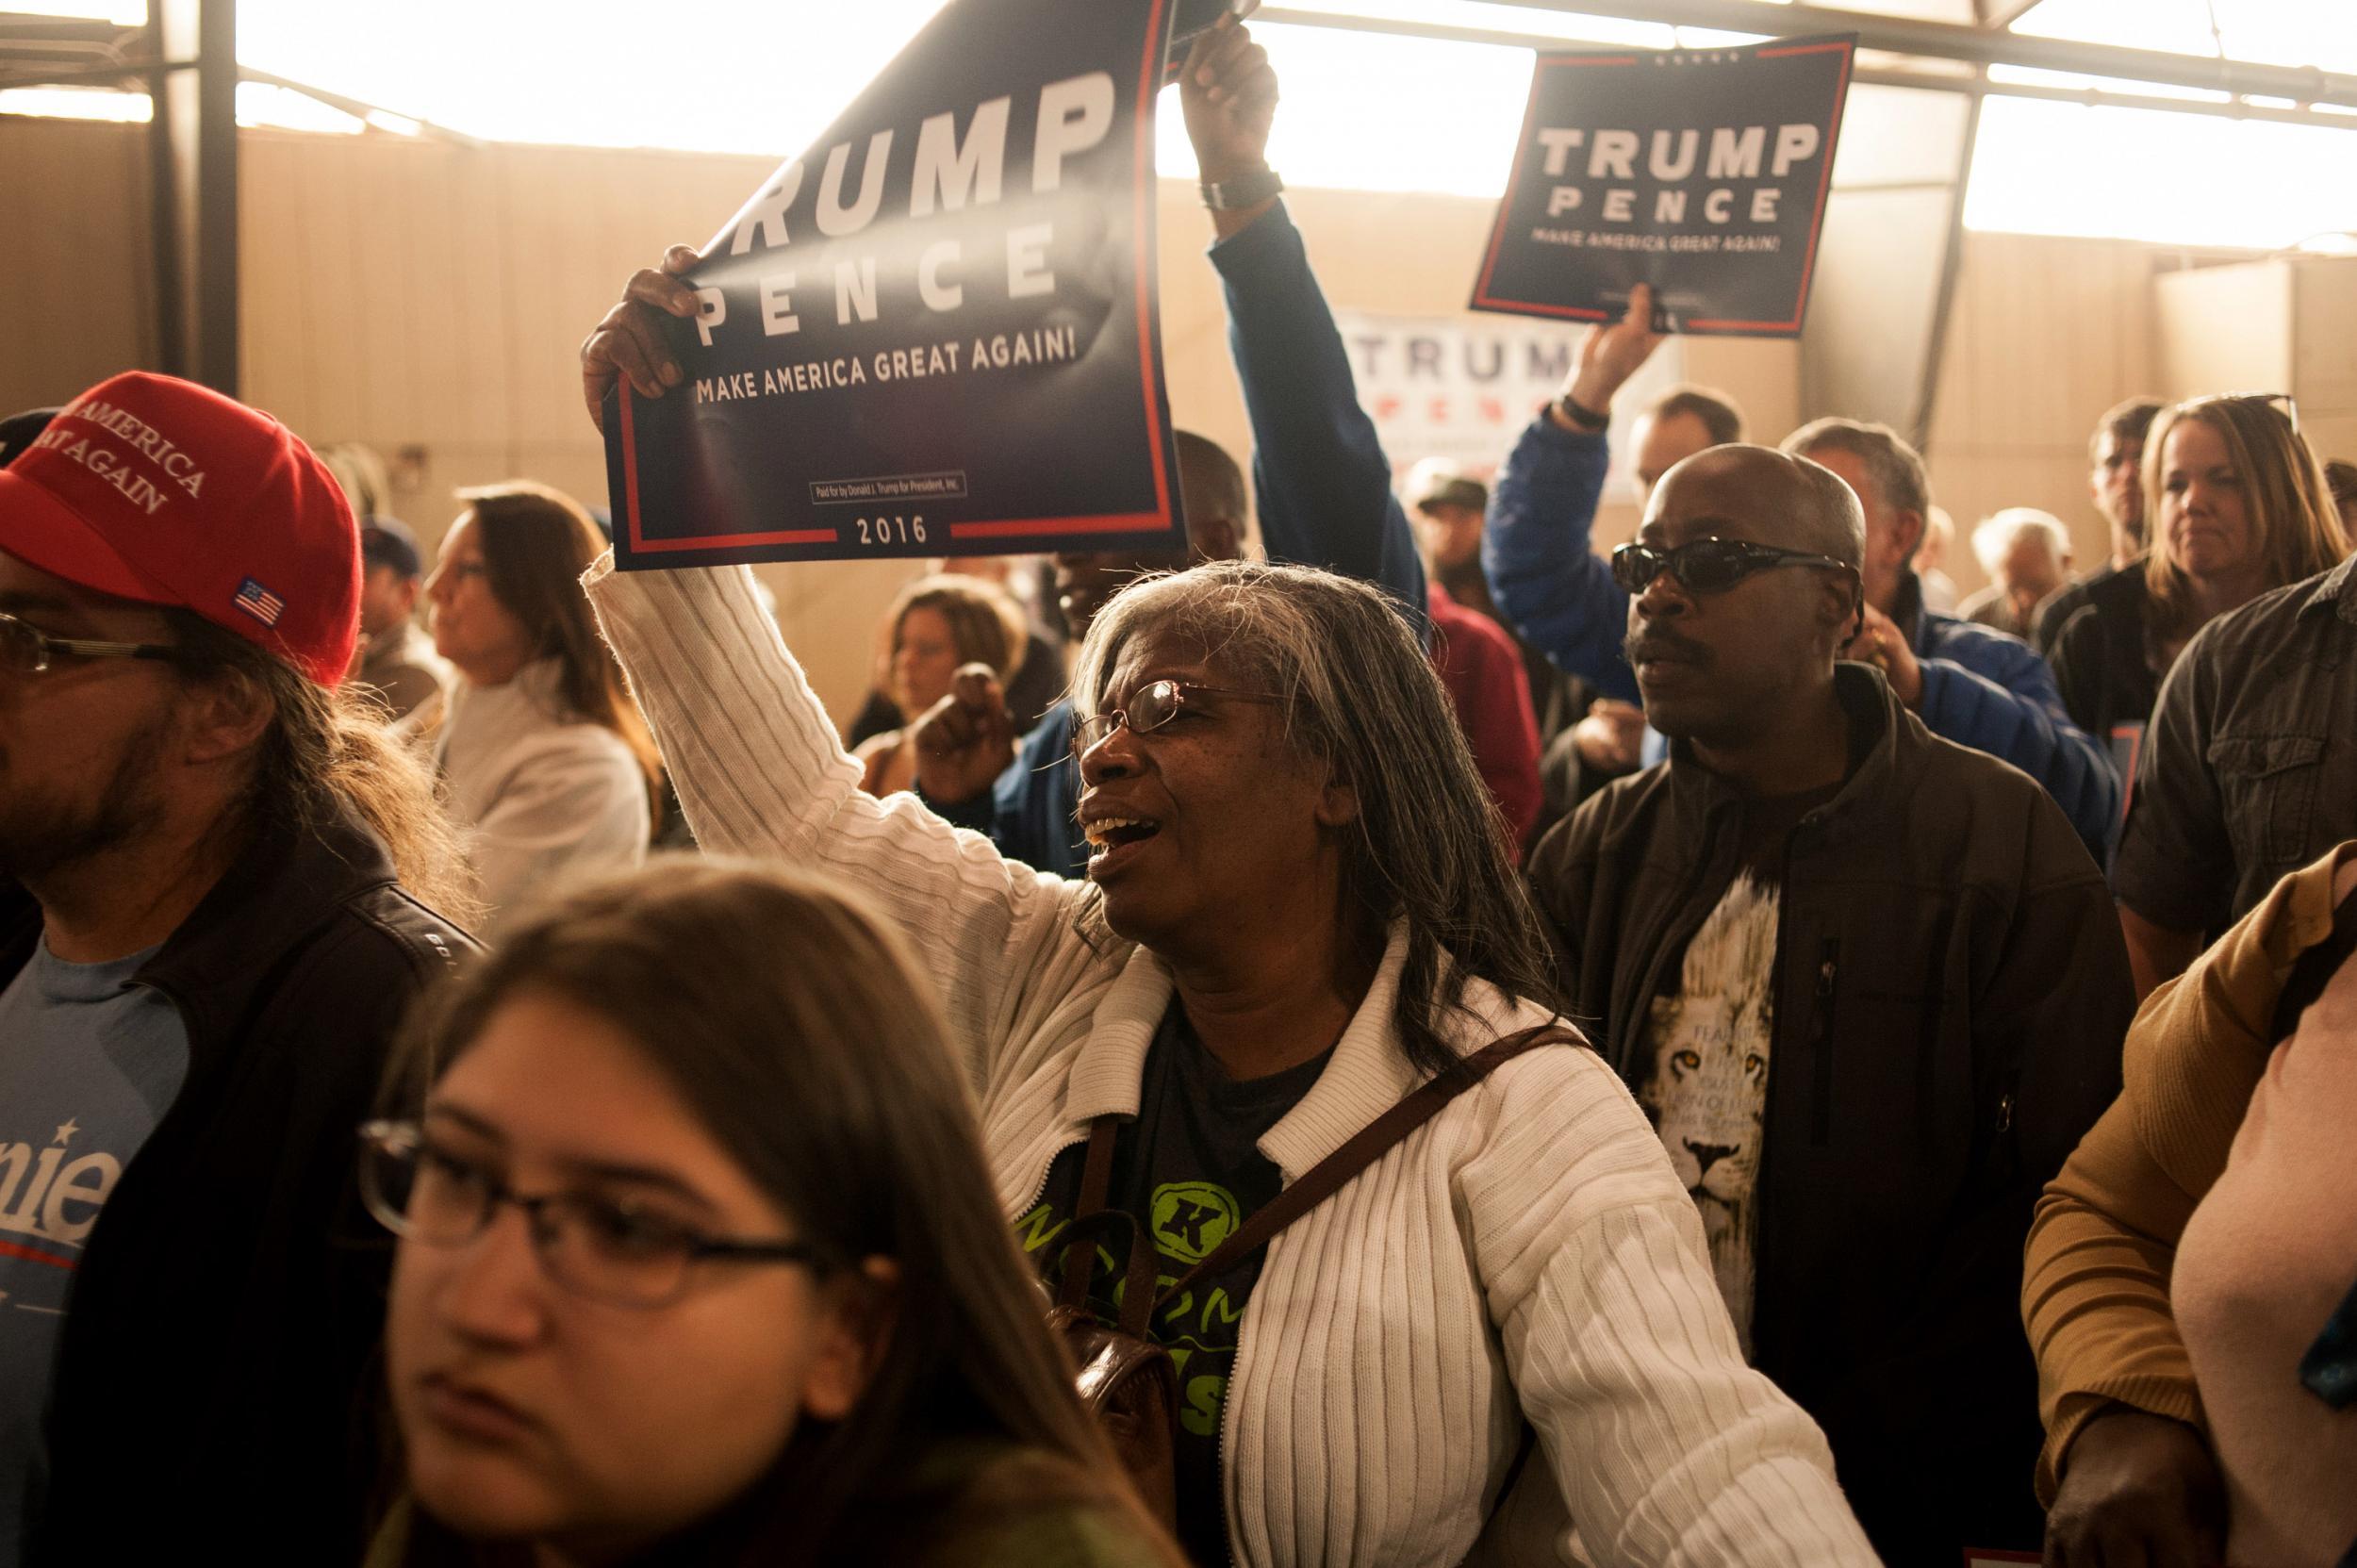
[0,371,361,686]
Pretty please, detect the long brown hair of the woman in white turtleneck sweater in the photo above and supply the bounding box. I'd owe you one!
[457,479,663,804]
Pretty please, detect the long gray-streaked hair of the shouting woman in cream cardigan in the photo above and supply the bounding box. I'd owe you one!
[1073,561,1554,1075]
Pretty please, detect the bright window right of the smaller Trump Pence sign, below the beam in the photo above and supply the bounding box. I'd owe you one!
[1964,94,2357,250]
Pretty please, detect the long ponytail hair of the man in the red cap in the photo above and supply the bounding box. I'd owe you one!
[165,608,484,924]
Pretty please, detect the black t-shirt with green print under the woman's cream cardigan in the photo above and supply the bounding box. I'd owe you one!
[1016,1002,1334,1563]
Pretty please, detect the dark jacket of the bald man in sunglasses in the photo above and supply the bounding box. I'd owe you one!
[1530,665,2134,1568]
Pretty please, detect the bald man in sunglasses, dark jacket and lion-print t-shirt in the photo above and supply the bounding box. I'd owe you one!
[1530,446,2134,1563]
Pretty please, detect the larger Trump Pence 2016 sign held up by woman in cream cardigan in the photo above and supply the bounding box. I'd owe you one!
[606,0,1186,570]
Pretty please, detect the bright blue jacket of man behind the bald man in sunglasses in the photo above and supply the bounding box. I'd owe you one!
[1480,413,2119,863]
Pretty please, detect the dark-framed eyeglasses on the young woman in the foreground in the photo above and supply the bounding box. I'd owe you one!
[361,1122,825,1309]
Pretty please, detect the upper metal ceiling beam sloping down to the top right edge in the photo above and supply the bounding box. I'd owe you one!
[1494,0,2357,108]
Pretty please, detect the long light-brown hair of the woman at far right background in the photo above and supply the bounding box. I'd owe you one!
[2145,394,2350,641]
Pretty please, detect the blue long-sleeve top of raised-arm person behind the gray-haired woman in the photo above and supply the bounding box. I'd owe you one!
[936,203,1426,877]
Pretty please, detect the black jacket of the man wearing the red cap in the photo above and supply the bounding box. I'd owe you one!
[0,801,474,1563]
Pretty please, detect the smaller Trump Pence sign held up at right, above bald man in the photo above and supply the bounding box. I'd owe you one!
[1474,36,1857,338]
